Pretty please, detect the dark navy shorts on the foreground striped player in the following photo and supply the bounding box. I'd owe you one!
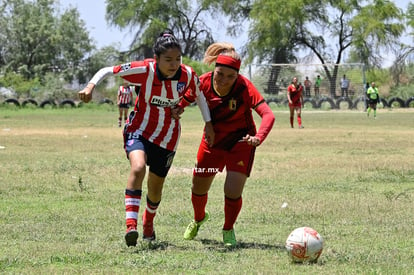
[124,133,175,178]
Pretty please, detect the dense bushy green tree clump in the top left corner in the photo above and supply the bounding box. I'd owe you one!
[0,0,93,80]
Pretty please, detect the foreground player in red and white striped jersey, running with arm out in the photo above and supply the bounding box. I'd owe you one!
[79,31,214,246]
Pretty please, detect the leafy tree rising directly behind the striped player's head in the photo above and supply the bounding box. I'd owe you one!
[106,0,213,59]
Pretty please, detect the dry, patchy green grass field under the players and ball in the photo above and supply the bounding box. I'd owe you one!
[0,104,414,274]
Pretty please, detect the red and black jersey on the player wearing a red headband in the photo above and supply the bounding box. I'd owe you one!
[200,72,264,150]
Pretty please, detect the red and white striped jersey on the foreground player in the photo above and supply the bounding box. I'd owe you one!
[90,59,210,151]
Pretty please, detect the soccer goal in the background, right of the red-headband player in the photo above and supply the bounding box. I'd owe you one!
[241,63,366,109]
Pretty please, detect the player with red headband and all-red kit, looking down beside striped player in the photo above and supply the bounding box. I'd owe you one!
[180,43,275,247]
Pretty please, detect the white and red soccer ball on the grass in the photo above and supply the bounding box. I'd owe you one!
[285,227,323,263]
